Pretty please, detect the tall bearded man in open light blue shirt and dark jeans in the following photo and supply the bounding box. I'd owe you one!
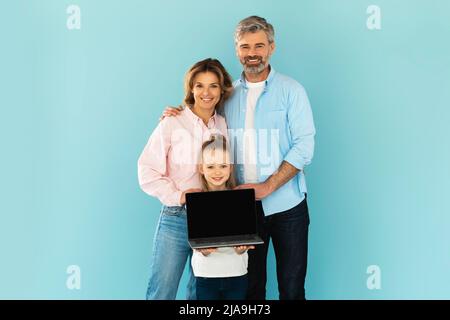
[164,16,315,300]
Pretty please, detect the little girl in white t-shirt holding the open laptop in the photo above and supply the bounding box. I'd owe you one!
[192,135,254,300]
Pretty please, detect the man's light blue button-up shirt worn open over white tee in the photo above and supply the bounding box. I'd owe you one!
[224,68,315,215]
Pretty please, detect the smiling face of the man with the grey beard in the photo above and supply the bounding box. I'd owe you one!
[236,30,275,74]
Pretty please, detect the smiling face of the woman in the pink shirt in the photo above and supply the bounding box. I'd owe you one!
[192,72,221,111]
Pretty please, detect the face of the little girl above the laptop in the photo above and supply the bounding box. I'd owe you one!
[200,149,231,189]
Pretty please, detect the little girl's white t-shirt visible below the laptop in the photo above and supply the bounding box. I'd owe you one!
[191,247,248,278]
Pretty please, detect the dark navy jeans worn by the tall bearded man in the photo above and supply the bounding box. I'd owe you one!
[247,198,309,300]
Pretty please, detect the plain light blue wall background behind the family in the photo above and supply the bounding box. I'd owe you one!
[0,0,450,299]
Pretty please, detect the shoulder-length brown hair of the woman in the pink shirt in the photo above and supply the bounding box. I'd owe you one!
[184,58,233,112]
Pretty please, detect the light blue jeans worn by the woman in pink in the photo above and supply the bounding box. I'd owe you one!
[147,206,196,300]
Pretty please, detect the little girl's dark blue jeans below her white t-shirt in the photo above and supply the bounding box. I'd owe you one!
[196,274,248,300]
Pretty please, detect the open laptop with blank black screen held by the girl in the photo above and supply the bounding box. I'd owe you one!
[186,189,264,249]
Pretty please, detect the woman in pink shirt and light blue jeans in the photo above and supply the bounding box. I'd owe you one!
[138,59,233,300]
